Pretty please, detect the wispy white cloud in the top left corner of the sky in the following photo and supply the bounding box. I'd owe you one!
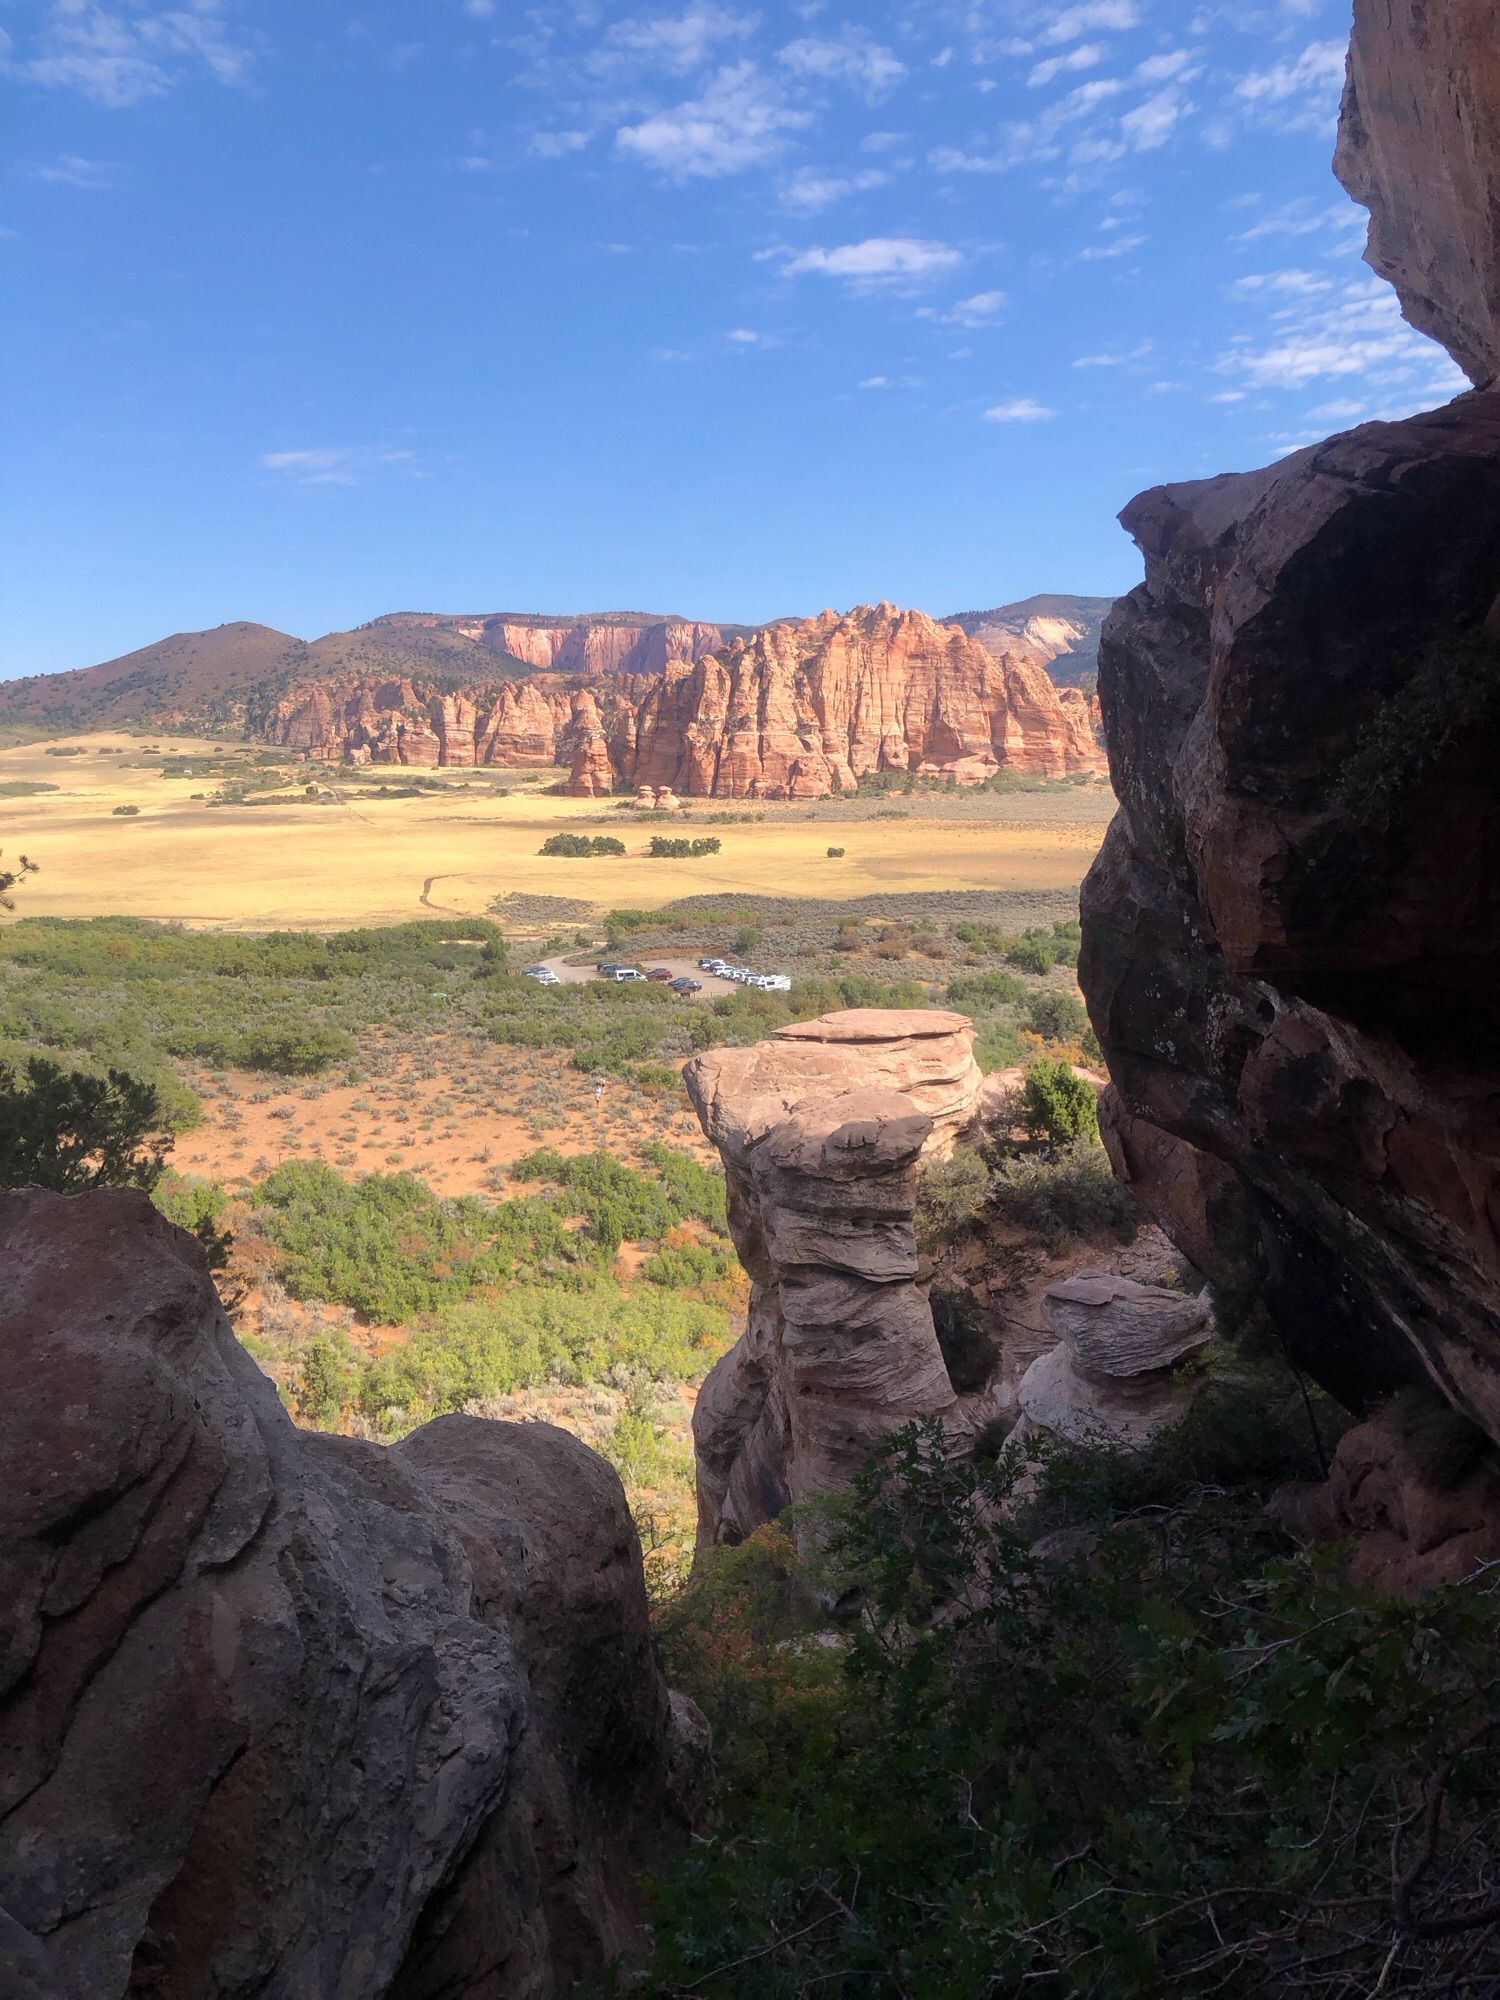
[0,0,250,110]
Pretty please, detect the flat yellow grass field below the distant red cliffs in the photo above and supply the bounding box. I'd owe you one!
[0,734,1112,930]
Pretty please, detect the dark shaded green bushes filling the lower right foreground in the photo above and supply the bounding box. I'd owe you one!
[632,1408,1500,2000]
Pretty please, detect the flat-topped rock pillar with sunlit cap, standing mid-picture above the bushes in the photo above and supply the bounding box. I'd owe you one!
[684,1008,980,1542]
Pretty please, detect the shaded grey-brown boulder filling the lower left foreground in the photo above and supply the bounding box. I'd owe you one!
[0,1192,682,2000]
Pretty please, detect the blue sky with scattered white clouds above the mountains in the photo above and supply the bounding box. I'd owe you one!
[0,0,1464,674]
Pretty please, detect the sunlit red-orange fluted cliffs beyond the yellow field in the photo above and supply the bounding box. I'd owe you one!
[266,604,1104,798]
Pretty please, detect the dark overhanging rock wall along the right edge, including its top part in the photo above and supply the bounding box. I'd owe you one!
[1080,0,1500,1436]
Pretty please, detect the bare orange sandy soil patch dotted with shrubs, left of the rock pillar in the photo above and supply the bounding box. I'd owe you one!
[172,1036,712,1196]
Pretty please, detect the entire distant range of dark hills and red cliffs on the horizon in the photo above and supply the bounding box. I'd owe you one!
[0,598,1104,798]
